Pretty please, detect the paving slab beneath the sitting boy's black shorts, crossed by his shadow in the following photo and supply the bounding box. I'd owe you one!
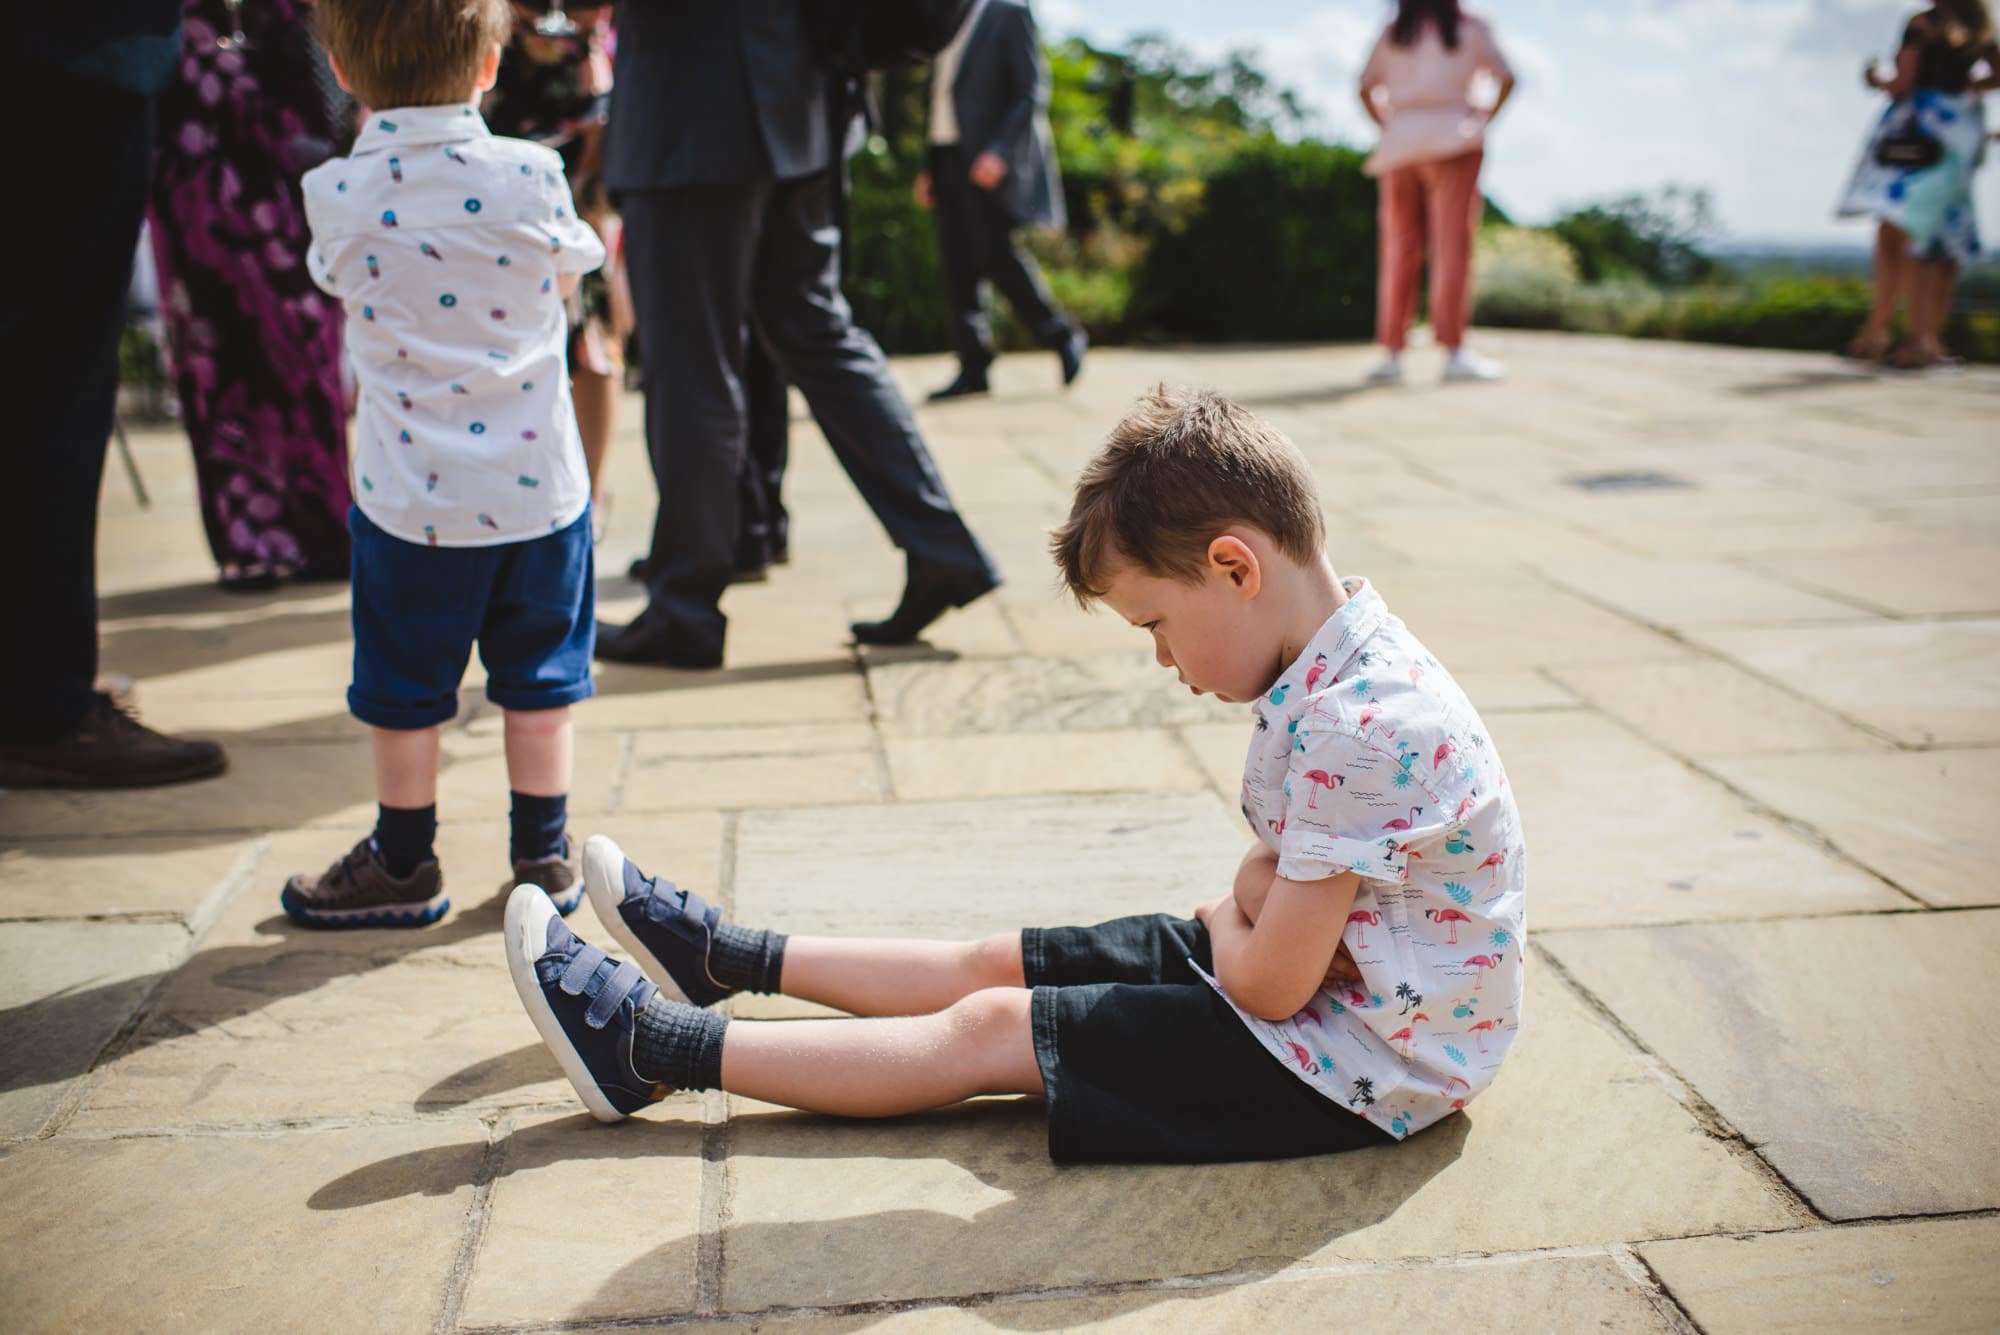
[720,973,1794,1311]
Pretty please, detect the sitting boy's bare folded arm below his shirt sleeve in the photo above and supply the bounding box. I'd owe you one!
[1208,871,1360,1021]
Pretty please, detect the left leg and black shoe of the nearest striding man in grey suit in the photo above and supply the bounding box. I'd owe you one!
[598,182,770,666]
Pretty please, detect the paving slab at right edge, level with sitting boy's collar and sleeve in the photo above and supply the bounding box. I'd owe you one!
[1714,749,2000,907]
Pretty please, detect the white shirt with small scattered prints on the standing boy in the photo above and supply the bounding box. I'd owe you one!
[304,106,604,548]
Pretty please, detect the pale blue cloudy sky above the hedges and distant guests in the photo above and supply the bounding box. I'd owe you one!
[1034,0,2000,248]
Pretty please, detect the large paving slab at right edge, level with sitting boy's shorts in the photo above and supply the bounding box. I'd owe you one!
[1536,909,2000,1219]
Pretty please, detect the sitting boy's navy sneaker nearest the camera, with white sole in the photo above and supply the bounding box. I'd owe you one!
[506,885,674,1121]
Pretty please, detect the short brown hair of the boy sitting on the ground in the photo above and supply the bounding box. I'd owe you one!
[1048,386,1326,606]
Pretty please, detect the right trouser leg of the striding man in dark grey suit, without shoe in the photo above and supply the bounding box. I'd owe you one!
[752,172,1000,595]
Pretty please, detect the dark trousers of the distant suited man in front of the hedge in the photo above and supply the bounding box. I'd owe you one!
[930,146,1072,372]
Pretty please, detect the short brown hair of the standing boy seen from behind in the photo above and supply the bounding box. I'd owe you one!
[318,0,512,108]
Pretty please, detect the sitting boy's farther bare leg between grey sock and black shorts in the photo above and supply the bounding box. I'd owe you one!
[776,931,1026,1015]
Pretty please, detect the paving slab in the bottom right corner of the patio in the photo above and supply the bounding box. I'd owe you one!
[1640,1217,2000,1335]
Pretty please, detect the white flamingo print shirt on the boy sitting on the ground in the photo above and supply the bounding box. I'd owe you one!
[1210,580,1526,1139]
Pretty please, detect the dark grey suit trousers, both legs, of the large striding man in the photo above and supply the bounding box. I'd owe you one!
[620,170,996,650]
